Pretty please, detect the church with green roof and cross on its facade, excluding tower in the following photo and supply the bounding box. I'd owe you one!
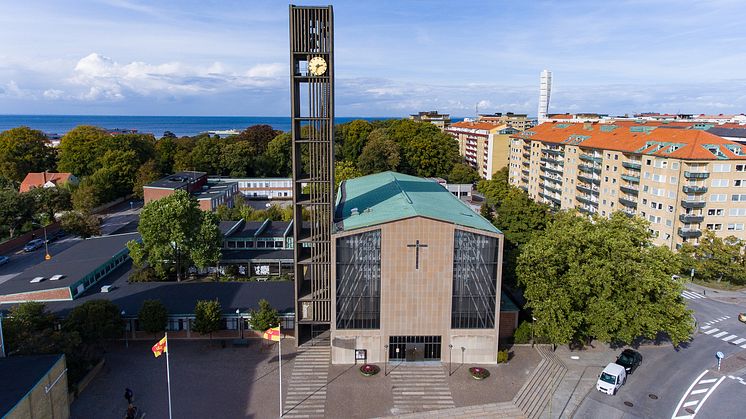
[330,172,503,364]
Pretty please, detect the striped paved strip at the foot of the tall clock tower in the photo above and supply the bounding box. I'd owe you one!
[283,344,331,418]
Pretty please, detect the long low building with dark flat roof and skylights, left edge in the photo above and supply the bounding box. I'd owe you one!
[0,233,140,304]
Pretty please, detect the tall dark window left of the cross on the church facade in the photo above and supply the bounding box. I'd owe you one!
[336,230,381,329]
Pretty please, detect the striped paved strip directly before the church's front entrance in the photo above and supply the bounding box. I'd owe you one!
[389,364,455,415]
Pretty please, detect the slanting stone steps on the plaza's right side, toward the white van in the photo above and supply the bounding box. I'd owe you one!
[513,345,567,419]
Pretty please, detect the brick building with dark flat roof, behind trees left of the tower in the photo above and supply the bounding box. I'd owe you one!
[143,172,238,211]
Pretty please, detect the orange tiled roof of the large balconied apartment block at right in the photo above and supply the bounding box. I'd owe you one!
[512,122,746,160]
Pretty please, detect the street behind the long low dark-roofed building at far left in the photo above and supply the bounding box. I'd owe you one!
[0,201,142,284]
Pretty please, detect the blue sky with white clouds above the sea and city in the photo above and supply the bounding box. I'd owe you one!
[0,0,746,117]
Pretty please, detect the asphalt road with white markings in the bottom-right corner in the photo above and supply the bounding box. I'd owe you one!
[574,291,746,419]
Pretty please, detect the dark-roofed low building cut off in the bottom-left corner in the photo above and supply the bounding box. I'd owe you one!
[0,355,70,419]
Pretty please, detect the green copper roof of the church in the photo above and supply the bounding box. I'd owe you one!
[334,172,500,233]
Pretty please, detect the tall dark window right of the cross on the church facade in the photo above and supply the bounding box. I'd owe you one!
[451,230,498,329]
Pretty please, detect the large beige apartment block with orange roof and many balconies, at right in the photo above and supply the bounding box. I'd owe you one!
[509,121,746,249]
